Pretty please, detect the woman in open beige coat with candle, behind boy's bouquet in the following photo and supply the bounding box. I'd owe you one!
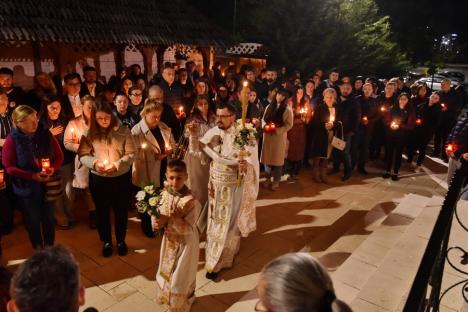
[132,100,175,237]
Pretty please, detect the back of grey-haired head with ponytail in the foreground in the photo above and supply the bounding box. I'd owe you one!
[255,253,351,312]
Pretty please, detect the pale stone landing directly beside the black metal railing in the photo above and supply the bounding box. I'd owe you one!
[350,197,443,312]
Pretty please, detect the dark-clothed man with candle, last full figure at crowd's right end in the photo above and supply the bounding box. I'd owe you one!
[433,79,462,162]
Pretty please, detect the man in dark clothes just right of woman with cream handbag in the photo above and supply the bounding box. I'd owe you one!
[332,82,361,181]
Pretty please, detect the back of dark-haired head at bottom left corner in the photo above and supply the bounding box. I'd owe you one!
[11,246,80,312]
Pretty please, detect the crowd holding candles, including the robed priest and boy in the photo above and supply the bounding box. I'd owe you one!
[0,62,468,311]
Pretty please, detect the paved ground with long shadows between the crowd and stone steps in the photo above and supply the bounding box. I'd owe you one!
[2,160,446,312]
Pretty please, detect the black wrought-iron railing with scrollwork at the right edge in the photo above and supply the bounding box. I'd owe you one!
[403,161,468,312]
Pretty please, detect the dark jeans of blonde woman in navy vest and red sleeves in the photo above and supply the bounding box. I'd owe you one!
[18,191,55,249]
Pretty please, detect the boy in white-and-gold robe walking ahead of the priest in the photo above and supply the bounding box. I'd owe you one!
[152,160,201,312]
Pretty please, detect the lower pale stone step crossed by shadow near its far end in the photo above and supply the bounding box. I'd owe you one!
[331,194,430,303]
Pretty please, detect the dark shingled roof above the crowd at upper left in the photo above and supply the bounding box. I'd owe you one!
[0,0,229,47]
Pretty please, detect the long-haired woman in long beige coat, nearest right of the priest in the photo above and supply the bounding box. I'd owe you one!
[260,89,293,191]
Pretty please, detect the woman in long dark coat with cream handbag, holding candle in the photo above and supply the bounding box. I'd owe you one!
[310,88,337,183]
